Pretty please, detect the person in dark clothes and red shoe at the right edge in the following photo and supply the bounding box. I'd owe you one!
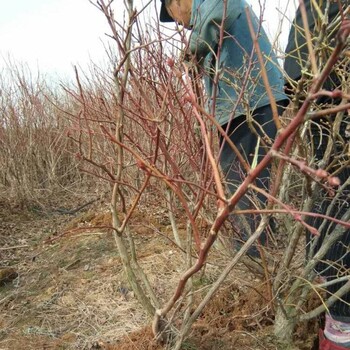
[284,0,350,350]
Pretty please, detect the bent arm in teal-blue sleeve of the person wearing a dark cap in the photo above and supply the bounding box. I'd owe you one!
[190,0,244,61]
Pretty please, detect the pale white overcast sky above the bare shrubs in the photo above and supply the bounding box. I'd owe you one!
[0,0,295,80]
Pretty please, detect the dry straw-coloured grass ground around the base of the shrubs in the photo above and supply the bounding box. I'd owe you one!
[0,200,316,350]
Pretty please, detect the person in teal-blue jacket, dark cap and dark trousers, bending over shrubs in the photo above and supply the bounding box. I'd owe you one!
[160,0,288,256]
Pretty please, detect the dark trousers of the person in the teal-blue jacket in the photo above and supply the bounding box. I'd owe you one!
[220,100,289,256]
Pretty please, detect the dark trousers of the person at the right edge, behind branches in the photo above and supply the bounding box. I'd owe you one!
[307,98,350,323]
